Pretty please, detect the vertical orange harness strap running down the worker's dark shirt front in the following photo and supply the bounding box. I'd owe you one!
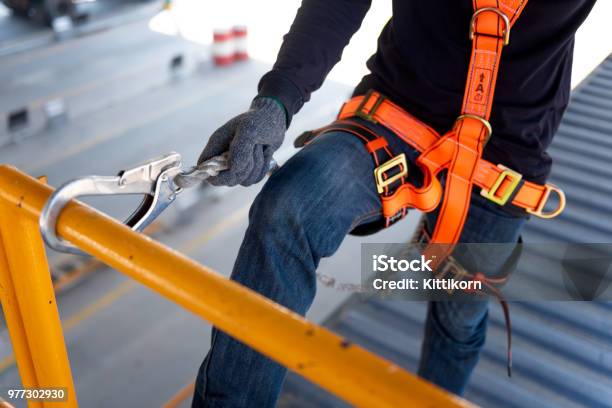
[423,0,527,247]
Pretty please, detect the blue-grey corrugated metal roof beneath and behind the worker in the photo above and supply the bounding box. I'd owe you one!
[280,56,612,407]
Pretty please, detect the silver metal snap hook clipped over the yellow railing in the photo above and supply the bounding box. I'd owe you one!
[39,152,182,255]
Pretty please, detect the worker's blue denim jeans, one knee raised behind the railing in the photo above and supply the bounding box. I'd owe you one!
[193,119,524,408]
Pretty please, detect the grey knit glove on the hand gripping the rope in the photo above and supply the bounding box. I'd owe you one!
[198,97,286,186]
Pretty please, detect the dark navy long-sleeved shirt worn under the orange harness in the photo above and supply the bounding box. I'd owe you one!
[258,0,595,182]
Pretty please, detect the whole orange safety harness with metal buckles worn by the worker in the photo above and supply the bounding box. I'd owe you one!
[295,0,565,374]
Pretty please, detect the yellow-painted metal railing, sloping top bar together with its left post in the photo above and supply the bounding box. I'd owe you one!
[0,166,471,407]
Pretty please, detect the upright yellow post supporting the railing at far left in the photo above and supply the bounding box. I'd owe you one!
[0,197,77,408]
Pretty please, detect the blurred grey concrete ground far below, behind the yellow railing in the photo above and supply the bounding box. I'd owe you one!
[0,7,415,407]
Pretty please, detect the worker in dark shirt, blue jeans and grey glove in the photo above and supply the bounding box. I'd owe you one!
[193,0,594,408]
